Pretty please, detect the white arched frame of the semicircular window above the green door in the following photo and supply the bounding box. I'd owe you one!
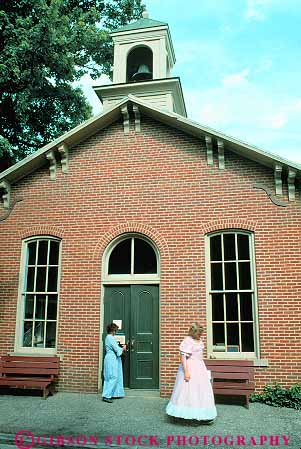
[102,233,160,284]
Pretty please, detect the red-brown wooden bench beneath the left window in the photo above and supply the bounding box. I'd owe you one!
[0,355,59,399]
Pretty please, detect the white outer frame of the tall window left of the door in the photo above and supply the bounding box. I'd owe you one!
[14,235,62,356]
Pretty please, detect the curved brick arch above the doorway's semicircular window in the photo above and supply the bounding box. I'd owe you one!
[93,222,169,261]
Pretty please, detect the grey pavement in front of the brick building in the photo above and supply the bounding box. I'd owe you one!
[0,390,301,449]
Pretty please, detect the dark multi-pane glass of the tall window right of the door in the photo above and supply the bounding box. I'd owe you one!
[208,231,257,357]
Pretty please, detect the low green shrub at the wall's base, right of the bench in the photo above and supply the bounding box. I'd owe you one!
[250,383,301,410]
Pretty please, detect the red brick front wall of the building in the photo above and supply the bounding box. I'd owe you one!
[0,117,301,396]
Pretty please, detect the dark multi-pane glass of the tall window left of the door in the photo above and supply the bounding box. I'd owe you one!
[19,237,61,351]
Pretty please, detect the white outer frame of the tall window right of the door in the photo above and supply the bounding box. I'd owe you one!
[205,229,260,360]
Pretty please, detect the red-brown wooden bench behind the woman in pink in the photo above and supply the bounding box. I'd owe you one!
[204,359,255,408]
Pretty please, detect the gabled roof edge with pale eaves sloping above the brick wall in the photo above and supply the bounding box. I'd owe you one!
[0,95,301,183]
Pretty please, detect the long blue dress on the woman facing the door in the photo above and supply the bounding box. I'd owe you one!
[102,334,124,398]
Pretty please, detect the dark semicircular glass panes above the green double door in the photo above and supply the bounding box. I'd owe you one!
[107,237,158,276]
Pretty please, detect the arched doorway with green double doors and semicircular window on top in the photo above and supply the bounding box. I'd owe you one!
[103,234,160,389]
